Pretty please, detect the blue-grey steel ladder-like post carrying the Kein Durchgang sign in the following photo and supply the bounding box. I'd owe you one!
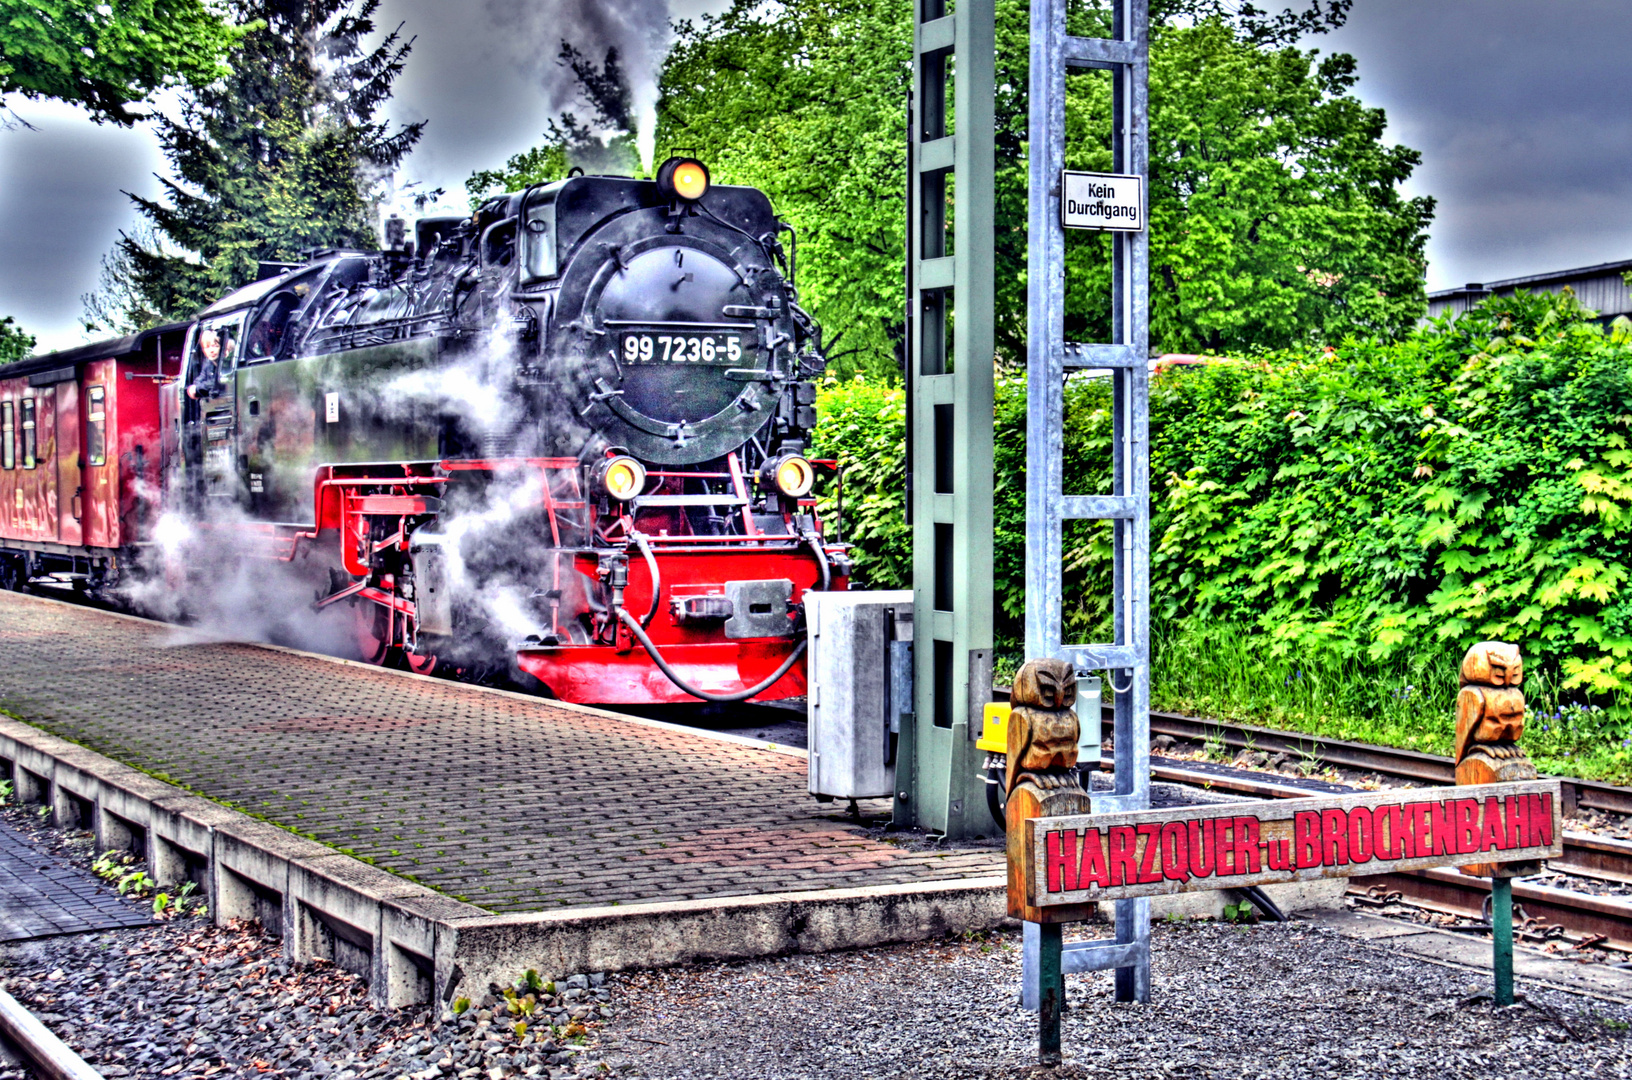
[1024,0,1151,1008]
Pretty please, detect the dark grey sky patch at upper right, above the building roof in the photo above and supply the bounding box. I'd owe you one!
[1310,0,1632,289]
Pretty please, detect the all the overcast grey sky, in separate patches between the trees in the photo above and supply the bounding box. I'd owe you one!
[0,0,1632,347]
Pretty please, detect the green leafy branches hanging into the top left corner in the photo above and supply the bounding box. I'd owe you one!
[0,0,246,124]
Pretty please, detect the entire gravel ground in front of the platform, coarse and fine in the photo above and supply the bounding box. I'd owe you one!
[0,809,1632,1080]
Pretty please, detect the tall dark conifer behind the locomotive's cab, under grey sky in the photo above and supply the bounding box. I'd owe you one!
[85,0,424,330]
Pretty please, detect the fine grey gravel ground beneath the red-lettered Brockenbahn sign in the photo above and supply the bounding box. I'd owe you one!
[602,922,1632,1080]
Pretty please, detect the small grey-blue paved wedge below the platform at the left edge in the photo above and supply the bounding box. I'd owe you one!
[0,821,153,941]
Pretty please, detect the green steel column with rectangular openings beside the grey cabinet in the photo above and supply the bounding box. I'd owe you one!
[896,0,996,837]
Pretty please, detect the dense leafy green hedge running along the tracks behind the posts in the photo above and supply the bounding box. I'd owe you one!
[816,287,1632,775]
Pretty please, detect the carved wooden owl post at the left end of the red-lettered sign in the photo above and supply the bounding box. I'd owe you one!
[1004,661,1093,922]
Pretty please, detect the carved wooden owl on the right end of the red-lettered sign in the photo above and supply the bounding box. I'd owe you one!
[1454,641,1541,878]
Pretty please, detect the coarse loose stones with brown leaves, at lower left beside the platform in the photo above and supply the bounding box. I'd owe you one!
[5,922,610,1080]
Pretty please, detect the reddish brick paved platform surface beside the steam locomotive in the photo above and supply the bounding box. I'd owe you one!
[0,594,1002,912]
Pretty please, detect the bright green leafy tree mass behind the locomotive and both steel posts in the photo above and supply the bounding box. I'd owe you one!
[658,0,1433,375]
